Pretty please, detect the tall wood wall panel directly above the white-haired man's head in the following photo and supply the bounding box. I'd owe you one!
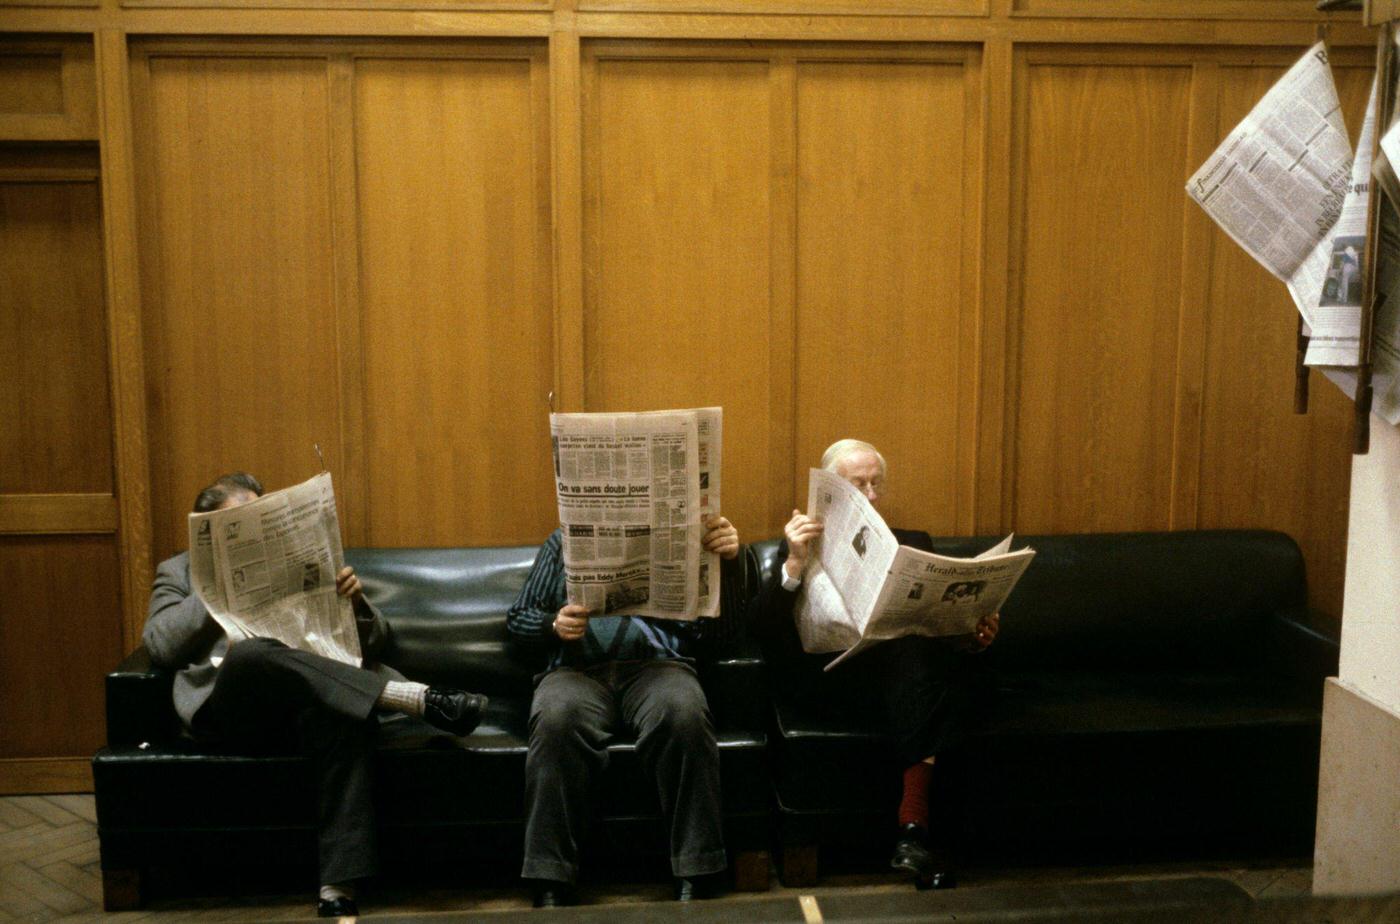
[792,54,980,532]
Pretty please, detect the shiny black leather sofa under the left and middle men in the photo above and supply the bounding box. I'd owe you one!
[92,546,771,909]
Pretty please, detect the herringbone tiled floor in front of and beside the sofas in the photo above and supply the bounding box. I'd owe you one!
[0,795,1312,921]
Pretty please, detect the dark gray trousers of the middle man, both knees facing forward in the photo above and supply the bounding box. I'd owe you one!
[521,661,725,882]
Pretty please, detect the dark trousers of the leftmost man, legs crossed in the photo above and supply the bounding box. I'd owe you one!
[192,638,385,883]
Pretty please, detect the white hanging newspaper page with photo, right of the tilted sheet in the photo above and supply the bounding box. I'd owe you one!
[1295,75,1376,365]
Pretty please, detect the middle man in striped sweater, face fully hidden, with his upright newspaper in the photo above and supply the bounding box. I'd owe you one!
[505,409,743,907]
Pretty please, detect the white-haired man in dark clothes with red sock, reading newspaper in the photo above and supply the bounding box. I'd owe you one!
[749,440,1001,889]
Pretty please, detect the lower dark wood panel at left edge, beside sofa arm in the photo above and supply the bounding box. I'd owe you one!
[0,536,122,757]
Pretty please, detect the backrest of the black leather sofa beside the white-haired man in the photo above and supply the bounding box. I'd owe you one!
[756,529,1308,671]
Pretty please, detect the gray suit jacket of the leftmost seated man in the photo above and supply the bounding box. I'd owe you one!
[141,552,402,728]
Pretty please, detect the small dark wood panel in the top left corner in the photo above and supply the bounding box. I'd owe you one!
[0,36,97,141]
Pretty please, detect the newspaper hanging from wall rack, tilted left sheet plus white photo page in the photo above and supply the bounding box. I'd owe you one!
[1186,42,1371,365]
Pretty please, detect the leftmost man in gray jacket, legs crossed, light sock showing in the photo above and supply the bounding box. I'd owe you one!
[141,472,486,917]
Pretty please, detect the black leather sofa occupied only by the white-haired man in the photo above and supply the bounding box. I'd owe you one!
[757,531,1337,879]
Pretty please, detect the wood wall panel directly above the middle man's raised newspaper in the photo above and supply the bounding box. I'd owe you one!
[584,56,787,536]
